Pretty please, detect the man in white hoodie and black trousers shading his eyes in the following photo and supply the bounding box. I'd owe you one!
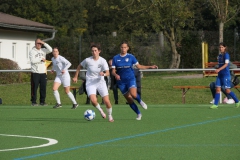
[29,38,52,106]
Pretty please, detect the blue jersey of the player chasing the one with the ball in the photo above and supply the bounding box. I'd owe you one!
[112,53,138,83]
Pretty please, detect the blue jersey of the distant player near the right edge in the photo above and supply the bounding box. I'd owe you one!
[218,52,230,77]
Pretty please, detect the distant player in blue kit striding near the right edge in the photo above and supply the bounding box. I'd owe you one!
[210,43,240,109]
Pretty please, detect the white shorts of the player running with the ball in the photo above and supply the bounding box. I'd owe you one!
[86,80,108,97]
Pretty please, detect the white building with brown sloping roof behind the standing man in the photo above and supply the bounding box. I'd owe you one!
[0,12,56,69]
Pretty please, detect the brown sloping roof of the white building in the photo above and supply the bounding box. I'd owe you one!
[0,12,56,32]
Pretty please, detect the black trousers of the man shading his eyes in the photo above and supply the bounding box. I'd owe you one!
[31,73,47,103]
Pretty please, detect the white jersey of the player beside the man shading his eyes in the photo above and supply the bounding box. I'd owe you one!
[52,55,72,76]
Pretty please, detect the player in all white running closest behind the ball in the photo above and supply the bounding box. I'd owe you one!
[73,45,114,122]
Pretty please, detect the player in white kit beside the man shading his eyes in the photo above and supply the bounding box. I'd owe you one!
[52,47,78,109]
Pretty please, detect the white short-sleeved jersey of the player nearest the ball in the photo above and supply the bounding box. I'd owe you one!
[80,56,109,85]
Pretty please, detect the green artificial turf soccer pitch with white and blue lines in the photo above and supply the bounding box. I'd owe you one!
[0,104,240,160]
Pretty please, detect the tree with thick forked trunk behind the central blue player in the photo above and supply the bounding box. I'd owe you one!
[111,0,194,68]
